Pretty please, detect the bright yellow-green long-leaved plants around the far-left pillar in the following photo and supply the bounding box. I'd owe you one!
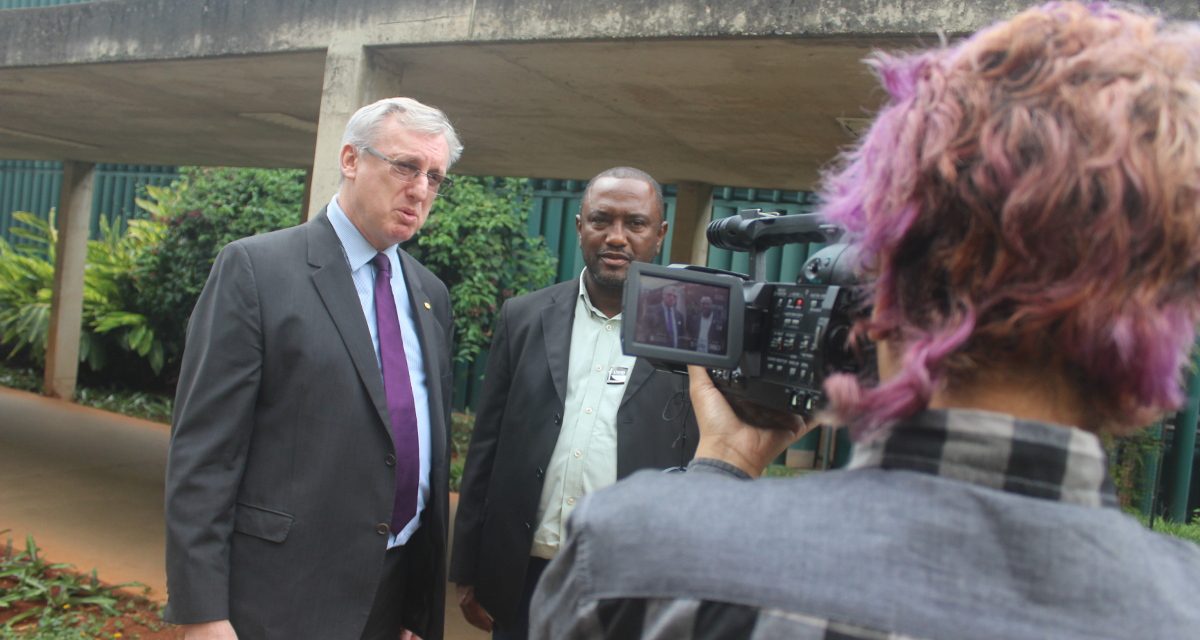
[0,210,163,373]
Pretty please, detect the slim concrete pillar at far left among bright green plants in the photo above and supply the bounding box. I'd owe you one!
[44,161,96,400]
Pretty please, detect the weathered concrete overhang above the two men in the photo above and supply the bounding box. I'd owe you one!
[0,0,1200,189]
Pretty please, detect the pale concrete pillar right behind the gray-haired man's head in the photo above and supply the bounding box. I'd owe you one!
[305,39,403,219]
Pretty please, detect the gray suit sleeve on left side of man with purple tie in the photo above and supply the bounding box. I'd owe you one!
[164,243,263,623]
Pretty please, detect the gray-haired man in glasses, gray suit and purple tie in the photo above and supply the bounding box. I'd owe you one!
[166,98,462,640]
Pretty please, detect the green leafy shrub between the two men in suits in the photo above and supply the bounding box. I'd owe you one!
[406,177,556,363]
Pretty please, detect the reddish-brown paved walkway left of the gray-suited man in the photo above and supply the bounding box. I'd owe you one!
[0,387,488,640]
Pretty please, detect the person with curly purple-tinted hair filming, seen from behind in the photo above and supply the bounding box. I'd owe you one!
[532,2,1200,640]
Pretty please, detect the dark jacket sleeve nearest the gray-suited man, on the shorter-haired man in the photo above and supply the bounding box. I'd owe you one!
[450,303,512,585]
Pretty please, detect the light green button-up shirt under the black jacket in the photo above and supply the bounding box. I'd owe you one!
[530,274,636,560]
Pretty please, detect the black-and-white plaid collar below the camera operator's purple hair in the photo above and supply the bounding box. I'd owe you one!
[848,409,1117,507]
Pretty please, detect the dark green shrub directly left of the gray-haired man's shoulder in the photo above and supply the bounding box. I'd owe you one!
[133,167,305,382]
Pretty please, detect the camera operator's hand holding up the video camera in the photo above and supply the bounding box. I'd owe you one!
[688,365,811,478]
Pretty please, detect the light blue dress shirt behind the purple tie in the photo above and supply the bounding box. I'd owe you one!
[325,196,432,549]
